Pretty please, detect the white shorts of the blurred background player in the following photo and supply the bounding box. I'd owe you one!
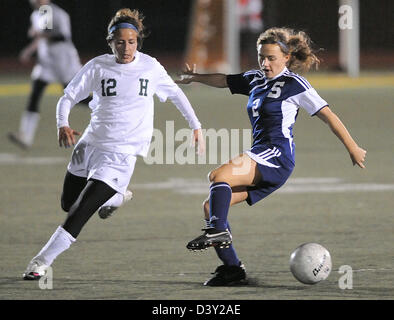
[31,41,82,84]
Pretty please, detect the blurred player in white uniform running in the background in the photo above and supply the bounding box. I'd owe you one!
[8,0,90,149]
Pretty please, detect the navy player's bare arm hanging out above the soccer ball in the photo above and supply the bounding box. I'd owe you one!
[316,106,367,168]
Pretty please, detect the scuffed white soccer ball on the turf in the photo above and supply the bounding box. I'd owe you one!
[290,243,332,284]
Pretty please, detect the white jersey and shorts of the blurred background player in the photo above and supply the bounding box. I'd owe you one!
[30,3,82,84]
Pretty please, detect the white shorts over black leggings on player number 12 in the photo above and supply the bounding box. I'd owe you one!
[67,140,137,194]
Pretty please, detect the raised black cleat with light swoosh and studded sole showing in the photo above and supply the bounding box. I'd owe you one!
[186,228,232,251]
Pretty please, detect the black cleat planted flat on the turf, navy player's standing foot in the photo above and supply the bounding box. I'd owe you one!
[204,262,248,287]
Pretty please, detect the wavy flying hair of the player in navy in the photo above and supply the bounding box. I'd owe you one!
[257,28,320,71]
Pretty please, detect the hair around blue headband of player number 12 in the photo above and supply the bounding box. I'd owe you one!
[106,8,147,50]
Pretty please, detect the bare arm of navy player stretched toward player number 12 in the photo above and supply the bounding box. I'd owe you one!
[175,64,228,88]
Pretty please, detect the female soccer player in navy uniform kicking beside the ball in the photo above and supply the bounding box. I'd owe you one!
[177,28,366,286]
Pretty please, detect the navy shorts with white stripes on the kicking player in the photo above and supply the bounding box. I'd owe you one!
[245,144,294,206]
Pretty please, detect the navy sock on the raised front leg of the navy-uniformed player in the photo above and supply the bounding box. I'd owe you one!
[209,182,232,231]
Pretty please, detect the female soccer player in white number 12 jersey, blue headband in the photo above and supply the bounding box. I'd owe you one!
[23,9,204,280]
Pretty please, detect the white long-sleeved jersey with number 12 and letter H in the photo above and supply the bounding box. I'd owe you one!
[57,51,201,156]
